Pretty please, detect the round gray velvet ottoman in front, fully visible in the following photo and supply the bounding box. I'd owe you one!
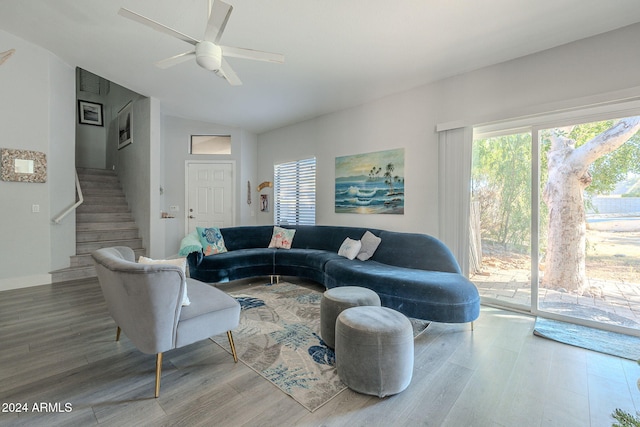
[335,307,413,397]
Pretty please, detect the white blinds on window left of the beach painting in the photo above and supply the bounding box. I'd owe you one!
[273,157,316,225]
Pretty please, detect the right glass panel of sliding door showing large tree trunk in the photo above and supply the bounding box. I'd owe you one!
[537,117,640,331]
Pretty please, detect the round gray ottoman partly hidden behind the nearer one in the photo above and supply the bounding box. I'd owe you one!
[320,286,380,348]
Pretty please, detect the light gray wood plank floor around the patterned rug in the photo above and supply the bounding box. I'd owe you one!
[0,280,640,427]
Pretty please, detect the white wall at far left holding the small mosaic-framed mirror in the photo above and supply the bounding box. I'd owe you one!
[0,30,75,290]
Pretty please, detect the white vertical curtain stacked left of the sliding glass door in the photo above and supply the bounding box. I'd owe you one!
[438,127,473,277]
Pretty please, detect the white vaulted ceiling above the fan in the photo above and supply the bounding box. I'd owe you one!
[0,0,640,133]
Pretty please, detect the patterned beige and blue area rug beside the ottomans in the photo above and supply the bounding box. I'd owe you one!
[212,282,429,412]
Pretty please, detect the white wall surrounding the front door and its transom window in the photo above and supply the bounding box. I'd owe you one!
[161,116,258,257]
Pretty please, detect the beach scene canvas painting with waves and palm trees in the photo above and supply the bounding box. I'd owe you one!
[335,148,404,215]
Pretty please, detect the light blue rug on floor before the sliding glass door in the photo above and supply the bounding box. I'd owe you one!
[533,317,640,360]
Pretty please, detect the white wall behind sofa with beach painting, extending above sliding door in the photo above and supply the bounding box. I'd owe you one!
[258,24,640,236]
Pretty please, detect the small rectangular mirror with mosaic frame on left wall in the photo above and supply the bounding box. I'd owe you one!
[1,148,47,182]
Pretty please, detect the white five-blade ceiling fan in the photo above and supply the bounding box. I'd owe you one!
[118,0,284,86]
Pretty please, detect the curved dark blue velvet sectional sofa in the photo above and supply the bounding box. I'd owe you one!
[187,226,480,323]
